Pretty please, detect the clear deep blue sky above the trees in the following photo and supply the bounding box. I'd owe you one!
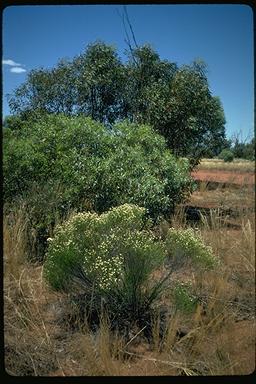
[2,4,254,140]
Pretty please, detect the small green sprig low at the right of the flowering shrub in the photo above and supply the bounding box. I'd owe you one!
[173,283,198,313]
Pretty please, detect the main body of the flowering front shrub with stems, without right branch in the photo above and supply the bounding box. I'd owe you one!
[44,204,168,325]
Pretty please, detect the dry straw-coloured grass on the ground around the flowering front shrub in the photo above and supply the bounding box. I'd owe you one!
[4,182,255,376]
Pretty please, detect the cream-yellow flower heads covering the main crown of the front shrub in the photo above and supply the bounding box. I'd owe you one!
[45,204,162,290]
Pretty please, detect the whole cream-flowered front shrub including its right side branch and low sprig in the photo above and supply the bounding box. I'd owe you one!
[44,204,220,329]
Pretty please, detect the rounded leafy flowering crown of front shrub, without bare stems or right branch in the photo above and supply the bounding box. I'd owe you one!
[44,204,165,293]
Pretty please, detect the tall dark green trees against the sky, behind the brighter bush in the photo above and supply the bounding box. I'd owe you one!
[8,41,225,164]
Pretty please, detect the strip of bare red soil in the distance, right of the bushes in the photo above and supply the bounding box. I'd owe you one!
[192,170,255,185]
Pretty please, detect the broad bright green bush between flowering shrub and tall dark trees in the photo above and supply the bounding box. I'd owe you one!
[3,114,192,259]
